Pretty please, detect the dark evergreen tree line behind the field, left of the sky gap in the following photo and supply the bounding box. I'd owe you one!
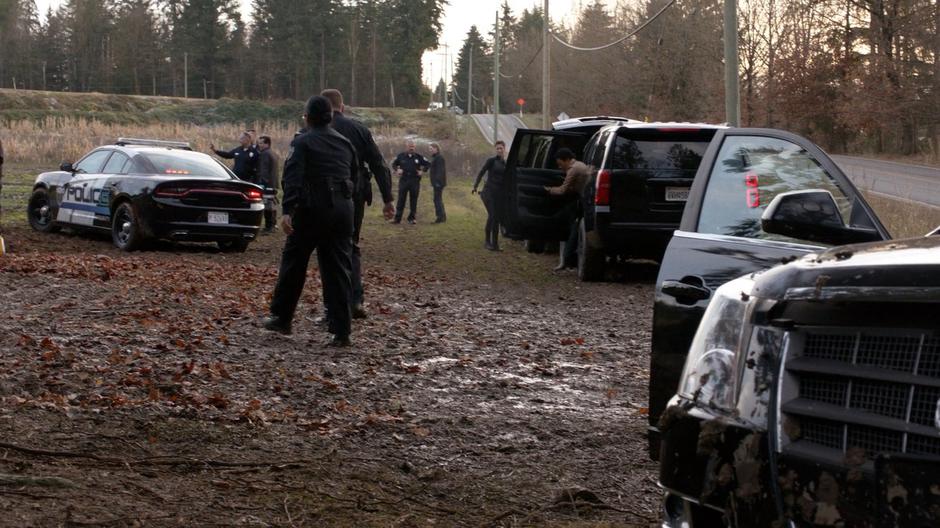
[0,0,445,106]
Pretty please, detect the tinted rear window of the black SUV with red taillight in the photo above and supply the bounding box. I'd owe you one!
[609,130,714,171]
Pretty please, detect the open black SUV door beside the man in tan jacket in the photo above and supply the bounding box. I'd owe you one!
[503,129,593,240]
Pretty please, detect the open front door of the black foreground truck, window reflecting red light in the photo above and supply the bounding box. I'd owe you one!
[649,128,889,458]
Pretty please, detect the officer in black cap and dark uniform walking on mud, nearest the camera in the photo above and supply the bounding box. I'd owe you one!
[263,95,359,346]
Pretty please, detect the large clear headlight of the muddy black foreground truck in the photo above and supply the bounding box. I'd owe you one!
[679,275,754,411]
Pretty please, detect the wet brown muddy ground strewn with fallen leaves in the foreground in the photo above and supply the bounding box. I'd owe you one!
[0,218,660,527]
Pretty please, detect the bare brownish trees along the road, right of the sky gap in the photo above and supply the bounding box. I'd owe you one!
[452,0,940,159]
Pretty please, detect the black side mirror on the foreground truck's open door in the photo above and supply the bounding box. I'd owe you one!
[760,189,881,246]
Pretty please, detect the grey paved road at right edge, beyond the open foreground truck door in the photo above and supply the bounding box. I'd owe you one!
[832,156,940,207]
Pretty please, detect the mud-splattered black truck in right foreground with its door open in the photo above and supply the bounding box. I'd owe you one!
[650,129,940,528]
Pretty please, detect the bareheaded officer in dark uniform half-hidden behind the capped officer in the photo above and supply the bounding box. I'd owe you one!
[320,88,395,319]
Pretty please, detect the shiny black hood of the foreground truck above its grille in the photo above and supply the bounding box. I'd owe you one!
[753,236,940,302]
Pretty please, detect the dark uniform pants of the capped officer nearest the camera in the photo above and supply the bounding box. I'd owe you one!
[271,193,353,336]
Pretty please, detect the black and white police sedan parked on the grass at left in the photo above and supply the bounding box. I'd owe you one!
[27,138,264,251]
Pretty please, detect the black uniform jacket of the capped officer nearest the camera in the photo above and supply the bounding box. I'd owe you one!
[282,126,359,215]
